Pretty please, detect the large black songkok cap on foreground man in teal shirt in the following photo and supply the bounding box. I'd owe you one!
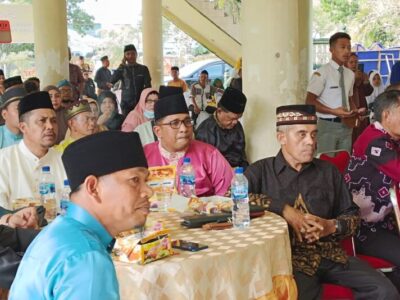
[62,130,147,192]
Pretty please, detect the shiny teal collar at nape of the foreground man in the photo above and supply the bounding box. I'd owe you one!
[65,202,113,249]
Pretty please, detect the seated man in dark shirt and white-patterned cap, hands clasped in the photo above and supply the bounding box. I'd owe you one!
[245,105,400,300]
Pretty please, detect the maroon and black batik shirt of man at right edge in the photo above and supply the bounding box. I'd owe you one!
[344,122,400,242]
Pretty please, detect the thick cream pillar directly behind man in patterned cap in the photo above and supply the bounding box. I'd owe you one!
[241,0,311,162]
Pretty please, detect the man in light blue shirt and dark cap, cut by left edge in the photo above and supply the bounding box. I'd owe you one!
[0,87,26,149]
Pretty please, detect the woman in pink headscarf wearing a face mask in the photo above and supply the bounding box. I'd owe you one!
[122,88,158,132]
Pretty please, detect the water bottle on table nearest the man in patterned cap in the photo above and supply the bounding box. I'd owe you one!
[231,167,250,229]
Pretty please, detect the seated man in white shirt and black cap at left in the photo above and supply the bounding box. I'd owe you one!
[0,92,67,209]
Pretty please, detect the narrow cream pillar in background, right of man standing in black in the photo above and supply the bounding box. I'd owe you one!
[142,0,163,89]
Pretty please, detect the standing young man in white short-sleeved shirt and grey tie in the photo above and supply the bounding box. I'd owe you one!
[306,32,362,152]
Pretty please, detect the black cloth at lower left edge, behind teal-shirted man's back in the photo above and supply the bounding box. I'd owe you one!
[0,225,39,289]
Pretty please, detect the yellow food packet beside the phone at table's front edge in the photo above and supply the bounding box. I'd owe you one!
[113,223,174,265]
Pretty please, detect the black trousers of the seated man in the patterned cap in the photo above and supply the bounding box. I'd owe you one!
[294,257,400,300]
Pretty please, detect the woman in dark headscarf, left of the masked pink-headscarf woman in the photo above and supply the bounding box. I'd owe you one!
[97,91,124,130]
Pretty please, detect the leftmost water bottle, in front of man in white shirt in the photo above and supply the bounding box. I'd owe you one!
[39,166,57,221]
